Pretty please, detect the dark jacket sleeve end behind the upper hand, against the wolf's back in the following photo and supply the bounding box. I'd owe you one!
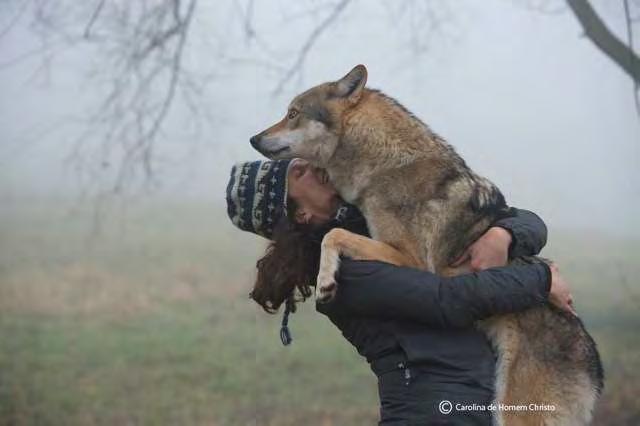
[493,208,547,259]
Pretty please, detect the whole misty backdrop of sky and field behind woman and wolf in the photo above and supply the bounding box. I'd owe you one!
[0,0,640,425]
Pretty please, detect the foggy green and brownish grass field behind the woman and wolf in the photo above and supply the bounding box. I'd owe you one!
[0,200,640,426]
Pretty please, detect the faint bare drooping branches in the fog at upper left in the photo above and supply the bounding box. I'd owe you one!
[70,0,199,192]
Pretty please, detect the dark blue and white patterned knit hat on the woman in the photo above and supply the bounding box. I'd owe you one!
[227,160,292,239]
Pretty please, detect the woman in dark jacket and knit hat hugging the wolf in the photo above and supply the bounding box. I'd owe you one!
[227,160,572,425]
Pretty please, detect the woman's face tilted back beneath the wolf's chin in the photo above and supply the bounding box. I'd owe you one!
[287,159,340,225]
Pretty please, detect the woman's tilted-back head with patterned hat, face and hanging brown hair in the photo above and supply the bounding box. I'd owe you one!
[227,160,340,313]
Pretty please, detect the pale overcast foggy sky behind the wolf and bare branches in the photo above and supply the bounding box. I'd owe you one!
[0,0,640,236]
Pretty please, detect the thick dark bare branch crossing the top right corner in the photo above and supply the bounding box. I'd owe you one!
[567,0,640,84]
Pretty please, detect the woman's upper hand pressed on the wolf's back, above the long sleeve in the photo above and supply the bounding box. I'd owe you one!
[451,226,512,272]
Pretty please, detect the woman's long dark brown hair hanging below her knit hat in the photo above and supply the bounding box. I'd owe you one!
[250,199,330,314]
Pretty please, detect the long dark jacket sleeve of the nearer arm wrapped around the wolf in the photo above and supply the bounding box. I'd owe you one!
[316,259,551,328]
